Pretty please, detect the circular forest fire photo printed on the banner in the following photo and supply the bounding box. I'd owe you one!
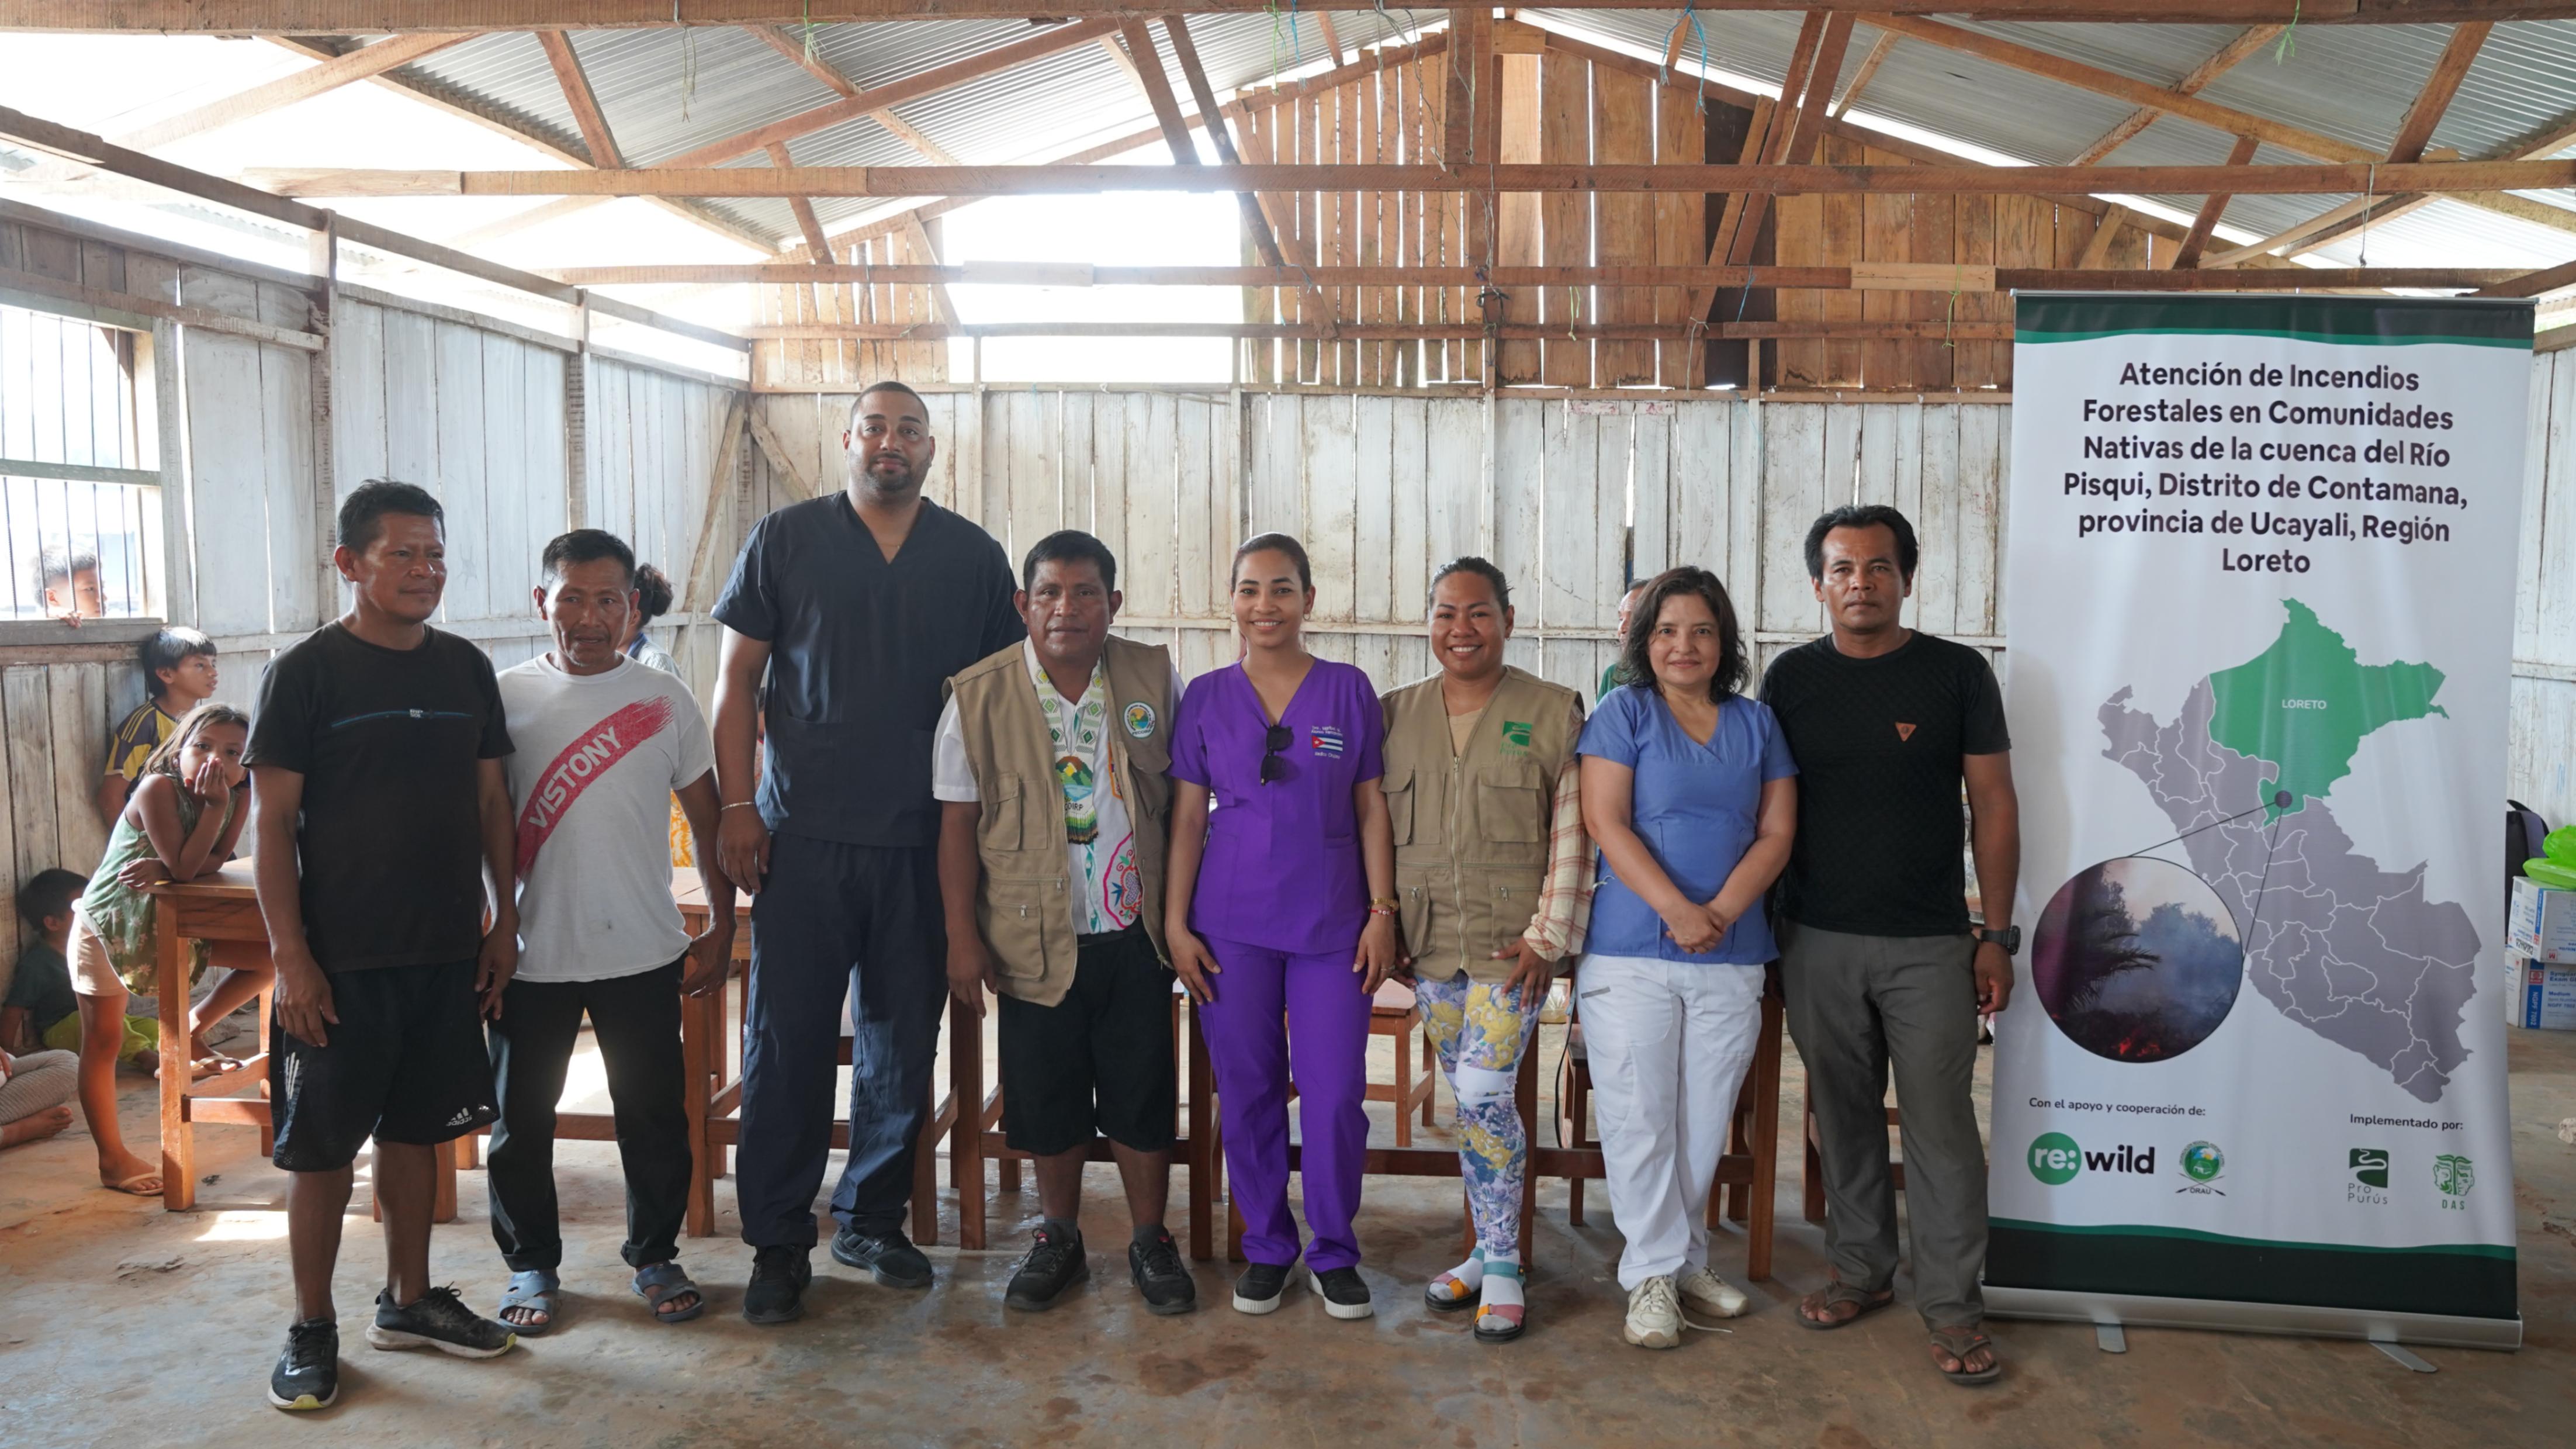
[2030,856,2243,1062]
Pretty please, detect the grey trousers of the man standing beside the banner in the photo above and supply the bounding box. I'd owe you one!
[1780,921,1986,1328]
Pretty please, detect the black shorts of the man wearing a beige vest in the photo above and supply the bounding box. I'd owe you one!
[999,928,1180,1158]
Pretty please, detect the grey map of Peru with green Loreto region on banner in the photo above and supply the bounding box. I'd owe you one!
[2100,598,2478,1101]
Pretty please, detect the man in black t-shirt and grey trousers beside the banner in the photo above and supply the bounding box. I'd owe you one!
[1762,506,2022,1385]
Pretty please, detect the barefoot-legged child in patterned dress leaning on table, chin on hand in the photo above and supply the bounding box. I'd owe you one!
[72,704,276,1196]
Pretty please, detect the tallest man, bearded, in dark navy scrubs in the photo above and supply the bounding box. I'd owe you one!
[716,382,1028,1323]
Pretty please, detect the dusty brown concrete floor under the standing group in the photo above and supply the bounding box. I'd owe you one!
[0,1011,2576,1449]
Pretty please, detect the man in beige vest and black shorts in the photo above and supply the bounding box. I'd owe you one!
[930,531,1198,1315]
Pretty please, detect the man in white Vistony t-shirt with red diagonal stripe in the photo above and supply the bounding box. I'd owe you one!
[490,528,734,1336]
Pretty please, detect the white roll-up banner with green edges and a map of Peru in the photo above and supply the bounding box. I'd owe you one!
[1986,294,2532,1348]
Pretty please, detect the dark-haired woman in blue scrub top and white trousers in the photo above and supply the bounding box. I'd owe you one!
[1574,567,1798,1348]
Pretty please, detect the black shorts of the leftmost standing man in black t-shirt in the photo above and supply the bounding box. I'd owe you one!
[268,962,497,1173]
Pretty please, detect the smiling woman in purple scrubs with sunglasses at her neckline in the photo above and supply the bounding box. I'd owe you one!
[1164,534,1396,1317]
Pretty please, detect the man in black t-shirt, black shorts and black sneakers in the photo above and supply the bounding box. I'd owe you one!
[245,479,518,1410]
